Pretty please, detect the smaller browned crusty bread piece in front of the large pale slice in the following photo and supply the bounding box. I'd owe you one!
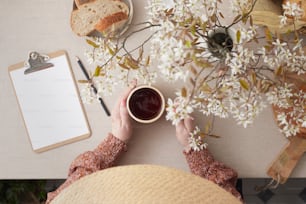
[95,12,128,32]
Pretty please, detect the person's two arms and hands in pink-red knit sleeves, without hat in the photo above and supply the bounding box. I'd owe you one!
[46,82,242,204]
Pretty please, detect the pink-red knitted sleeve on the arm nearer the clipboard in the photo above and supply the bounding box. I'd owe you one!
[46,133,126,204]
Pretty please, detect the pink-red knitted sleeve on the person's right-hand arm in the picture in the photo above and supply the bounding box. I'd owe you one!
[184,149,242,201]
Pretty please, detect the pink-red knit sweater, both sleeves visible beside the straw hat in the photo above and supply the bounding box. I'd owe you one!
[46,133,241,204]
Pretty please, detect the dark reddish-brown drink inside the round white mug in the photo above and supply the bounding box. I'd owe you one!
[128,87,163,120]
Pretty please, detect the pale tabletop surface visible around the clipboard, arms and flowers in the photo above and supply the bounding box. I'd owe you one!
[0,0,306,179]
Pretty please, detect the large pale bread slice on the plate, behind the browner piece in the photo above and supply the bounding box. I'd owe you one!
[71,0,129,36]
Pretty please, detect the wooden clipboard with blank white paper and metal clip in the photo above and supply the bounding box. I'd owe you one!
[8,50,91,152]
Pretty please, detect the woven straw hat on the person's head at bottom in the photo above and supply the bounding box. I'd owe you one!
[52,165,240,204]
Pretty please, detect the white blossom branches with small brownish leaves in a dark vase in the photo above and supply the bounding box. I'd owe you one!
[82,0,306,149]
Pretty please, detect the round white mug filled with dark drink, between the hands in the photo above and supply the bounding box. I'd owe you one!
[126,85,165,123]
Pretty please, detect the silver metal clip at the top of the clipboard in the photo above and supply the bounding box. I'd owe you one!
[24,51,54,74]
